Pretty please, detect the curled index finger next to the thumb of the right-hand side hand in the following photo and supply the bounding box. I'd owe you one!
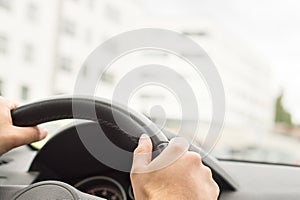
[148,137,189,171]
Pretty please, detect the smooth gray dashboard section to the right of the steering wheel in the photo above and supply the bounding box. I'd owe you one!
[220,161,300,200]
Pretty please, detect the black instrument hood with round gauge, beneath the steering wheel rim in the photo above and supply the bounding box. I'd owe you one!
[29,122,134,200]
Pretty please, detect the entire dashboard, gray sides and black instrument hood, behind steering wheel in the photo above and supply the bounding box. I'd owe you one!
[0,123,300,200]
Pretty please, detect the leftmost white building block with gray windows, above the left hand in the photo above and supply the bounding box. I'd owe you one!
[0,0,56,101]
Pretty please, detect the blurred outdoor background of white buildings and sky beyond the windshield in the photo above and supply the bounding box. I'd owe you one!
[0,0,300,164]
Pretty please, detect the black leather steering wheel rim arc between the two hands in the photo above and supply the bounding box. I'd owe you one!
[11,96,169,154]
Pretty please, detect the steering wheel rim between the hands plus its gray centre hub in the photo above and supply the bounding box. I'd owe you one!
[7,97,168,200]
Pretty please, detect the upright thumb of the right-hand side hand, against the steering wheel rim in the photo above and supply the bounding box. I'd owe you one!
[132,134,152,172]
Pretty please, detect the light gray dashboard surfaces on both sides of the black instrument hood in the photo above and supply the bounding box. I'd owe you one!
[0,129,300,200]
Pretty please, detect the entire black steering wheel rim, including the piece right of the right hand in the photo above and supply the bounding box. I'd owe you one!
[11,96,238,196]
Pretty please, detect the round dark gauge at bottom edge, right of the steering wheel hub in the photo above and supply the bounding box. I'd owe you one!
[75,176,127,200]
